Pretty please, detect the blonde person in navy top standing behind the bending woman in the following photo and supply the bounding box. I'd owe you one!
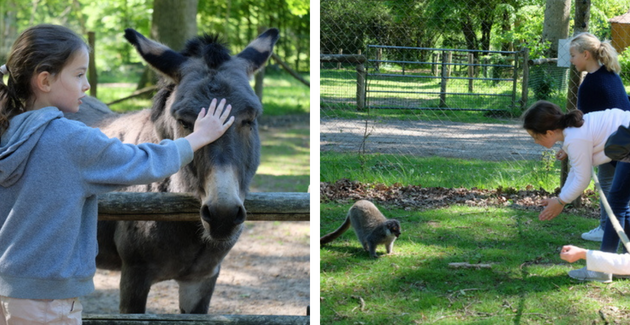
[559,33,630,241]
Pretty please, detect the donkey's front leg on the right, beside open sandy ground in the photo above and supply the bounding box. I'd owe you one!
[177,266,220,314]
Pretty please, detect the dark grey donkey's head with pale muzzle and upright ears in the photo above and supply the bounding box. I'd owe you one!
[125,29,278,241]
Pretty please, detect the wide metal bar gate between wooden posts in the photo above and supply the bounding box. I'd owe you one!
[365,45,523,111]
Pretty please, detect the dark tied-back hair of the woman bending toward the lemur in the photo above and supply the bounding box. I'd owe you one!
[521,100,584,134]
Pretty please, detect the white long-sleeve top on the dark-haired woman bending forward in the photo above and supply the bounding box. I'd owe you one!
[558,108,630,202]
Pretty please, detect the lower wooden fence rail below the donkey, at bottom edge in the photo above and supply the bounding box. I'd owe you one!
[83,314,310,325]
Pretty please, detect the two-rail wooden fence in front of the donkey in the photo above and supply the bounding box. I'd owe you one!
[83,192,310,325]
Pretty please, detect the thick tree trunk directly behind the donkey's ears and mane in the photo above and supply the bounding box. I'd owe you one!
[138,0,198,89]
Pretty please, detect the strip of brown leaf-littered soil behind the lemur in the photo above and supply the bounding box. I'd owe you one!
[320,179,599,218]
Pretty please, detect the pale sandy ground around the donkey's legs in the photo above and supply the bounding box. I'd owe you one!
[81,118,310,315]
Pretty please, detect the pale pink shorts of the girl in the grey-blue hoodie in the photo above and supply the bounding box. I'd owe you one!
[0,296,83,325]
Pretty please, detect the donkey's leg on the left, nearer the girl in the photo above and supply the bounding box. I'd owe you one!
[119,264,152,314]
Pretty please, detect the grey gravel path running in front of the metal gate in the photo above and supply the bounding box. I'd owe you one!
[320,119,559,160]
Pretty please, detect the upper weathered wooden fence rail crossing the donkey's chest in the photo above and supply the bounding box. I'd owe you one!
[98,192,310,221]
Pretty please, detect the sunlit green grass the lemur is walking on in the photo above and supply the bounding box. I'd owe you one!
[320,204,630,324]
